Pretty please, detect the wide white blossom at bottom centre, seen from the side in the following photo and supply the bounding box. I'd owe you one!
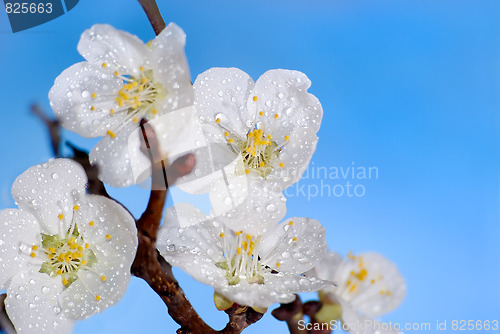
[157,204,329,308]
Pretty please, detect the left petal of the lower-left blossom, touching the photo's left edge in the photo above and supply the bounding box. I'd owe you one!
[0,209,40,289]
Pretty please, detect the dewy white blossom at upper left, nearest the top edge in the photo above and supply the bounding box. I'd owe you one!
[49,23,193,187]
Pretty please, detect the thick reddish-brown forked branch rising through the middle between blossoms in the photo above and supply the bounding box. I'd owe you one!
[131,121,263,334]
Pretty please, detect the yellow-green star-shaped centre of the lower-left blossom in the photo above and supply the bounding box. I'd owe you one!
[40,224,97,287]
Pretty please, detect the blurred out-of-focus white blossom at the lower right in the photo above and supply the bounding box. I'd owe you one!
[310,252,406,334]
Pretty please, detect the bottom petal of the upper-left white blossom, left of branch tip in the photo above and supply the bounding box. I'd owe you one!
[90,122,143,187]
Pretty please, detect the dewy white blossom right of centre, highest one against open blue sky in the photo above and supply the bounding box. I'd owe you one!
[194,68,323,191]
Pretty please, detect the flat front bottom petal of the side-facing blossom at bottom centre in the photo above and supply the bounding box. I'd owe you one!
[218,273,330,308]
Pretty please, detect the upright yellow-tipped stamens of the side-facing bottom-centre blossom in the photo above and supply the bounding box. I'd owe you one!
[216,232,267,285]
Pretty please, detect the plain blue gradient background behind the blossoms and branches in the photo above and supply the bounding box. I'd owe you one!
[0,0,500,334]
